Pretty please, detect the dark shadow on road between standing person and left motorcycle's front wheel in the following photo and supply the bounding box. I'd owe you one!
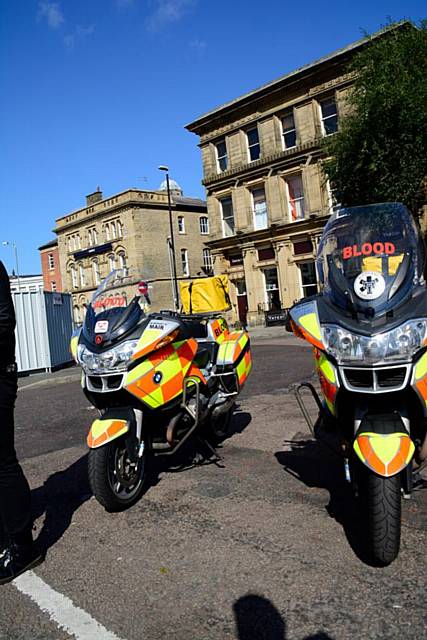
[31,454,92,552]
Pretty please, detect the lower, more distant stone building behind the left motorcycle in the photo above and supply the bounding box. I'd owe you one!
[54,180,212,322]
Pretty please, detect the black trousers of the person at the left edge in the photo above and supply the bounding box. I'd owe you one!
[0,372,32,546]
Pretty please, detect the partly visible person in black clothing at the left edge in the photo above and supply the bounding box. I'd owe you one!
[0,262,41,584]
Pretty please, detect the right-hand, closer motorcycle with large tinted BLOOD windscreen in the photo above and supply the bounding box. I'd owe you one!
[290,203,427,565]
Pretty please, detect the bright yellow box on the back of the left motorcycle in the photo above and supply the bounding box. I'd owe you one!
[179,275,231,313]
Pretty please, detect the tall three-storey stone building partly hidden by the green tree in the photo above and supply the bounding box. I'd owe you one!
[186,26,402,324]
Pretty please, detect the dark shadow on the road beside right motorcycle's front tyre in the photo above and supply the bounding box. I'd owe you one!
[275,440,372,566]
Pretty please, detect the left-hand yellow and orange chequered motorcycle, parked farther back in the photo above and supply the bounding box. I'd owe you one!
[70,269,252,511]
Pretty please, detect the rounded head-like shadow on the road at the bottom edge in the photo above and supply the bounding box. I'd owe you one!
[233,593,333,640]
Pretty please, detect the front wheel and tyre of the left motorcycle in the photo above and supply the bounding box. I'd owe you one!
[88,438,148,511]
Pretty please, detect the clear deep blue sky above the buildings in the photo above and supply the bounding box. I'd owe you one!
[0,0,426,273]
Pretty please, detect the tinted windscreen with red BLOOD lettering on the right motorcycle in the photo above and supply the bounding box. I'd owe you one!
[317,203,423,315]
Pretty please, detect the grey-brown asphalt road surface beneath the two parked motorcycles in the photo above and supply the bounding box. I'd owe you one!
[0,339,427,640]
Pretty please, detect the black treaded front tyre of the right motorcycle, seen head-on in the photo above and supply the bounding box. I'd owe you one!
[366,471,401,565]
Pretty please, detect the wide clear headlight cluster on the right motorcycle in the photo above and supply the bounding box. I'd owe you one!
[322,320,427,364]
